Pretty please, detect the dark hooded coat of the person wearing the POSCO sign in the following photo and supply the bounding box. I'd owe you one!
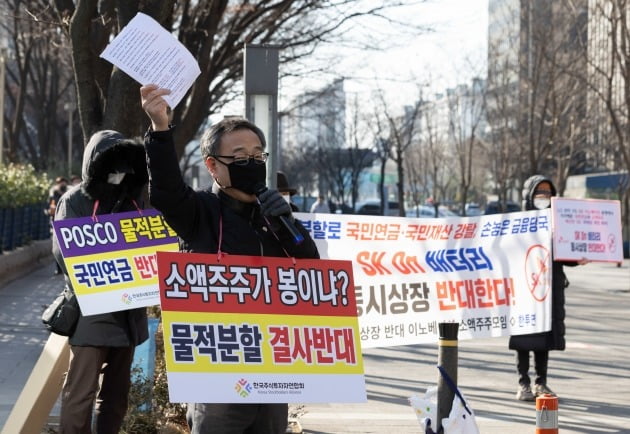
[53,130,149,347]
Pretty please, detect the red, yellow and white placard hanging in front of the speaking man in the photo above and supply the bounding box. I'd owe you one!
[157,252,366,403]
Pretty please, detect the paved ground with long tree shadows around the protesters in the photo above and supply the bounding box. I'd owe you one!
[0,246,630,434]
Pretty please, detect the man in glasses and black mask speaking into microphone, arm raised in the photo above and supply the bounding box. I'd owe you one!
[140,85,319,434]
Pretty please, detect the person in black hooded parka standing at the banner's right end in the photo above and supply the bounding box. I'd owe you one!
[509,175,586,401]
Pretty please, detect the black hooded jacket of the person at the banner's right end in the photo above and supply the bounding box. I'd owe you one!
[509,175,577,351]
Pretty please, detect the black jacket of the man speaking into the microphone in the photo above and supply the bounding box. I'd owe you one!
[145,130,319,258]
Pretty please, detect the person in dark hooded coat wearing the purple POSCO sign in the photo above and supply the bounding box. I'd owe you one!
[53,130,149,434]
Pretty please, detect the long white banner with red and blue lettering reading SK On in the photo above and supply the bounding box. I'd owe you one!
[296,210,551,348]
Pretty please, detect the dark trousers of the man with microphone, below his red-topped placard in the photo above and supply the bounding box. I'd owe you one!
[186,404,289,434]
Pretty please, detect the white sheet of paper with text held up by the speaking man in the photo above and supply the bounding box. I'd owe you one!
[100,12,201,108]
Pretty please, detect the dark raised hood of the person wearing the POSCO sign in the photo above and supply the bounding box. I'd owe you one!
[81,130,149,201]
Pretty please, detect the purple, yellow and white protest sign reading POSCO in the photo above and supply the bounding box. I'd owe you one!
[53,210,178,315]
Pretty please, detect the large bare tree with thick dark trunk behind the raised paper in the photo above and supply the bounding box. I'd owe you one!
[49,0,430,155]
